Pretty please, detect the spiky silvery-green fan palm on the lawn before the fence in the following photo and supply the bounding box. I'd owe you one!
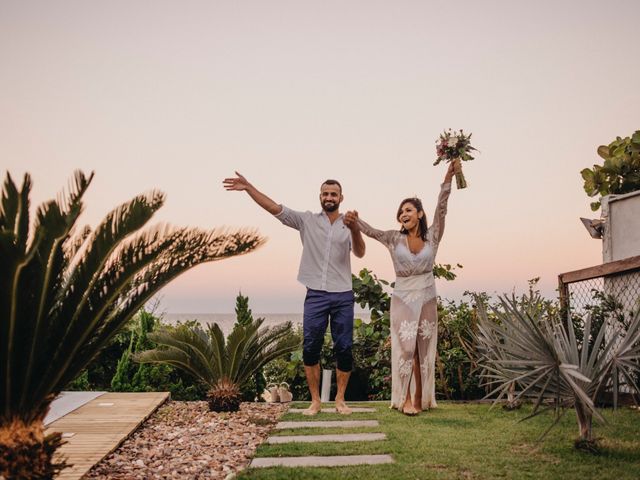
[476,296,640,449]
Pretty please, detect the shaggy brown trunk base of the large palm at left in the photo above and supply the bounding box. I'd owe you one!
[0,419,71,479]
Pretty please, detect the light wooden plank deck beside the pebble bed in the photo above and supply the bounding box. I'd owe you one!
[47,392,169,480]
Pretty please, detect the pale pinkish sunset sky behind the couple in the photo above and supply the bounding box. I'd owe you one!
[0,0,640,313]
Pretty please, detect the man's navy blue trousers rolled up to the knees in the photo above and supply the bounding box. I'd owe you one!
[302,288,353,372]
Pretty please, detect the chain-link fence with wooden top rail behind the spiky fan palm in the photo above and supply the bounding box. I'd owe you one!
[558,256,640,393]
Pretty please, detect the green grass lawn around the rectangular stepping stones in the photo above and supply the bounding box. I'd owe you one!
[238,402,640,480]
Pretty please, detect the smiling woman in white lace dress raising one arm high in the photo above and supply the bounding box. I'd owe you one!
[344,162,454,415]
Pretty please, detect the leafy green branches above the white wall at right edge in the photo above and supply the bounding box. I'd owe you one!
[580,130,640,211]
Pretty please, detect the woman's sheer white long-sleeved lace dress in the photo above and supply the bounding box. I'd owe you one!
[359,183,451,409]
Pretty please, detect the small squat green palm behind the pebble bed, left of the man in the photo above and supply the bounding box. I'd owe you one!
[134,318,298,412]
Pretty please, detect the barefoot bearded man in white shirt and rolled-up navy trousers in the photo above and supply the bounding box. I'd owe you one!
[223,172,365,415]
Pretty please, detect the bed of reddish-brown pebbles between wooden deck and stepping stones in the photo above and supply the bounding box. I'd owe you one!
[83,401,287,480]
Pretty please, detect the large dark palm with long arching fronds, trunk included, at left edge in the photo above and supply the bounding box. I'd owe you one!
[0,171,263,478]
